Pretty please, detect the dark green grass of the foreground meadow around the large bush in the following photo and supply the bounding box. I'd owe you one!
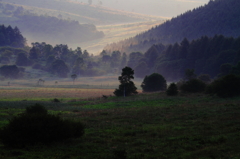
[0,94,240,159]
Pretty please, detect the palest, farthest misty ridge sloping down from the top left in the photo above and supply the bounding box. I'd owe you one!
[2,0,156,25]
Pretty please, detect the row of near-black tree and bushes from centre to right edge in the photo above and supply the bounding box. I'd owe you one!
[114,63,240,98]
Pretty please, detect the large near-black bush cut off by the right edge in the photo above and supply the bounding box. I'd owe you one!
[206,75,240,98]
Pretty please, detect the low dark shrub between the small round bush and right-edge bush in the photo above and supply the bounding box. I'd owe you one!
[180,79,206,93]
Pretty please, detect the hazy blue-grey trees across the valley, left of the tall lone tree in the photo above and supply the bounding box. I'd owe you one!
[0,31,127,78]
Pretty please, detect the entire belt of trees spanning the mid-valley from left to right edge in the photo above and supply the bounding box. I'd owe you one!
[0,35,240,81]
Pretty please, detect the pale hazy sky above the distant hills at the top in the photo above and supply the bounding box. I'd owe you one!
[77,0,209,17]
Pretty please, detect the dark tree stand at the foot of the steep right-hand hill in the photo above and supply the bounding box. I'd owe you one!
[117,35,240,81]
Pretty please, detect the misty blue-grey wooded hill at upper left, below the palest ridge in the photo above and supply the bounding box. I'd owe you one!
[0,4,104,44]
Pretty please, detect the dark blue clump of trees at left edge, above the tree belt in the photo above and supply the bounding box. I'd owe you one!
[0,25,26,47]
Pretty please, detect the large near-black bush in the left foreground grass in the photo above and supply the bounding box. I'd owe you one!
[0,105,84,147]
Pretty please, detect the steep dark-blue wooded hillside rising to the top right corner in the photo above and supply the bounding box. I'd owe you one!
[105,0,240,53]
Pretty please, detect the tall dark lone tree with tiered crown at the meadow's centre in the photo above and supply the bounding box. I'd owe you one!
[113,67,138,97]
